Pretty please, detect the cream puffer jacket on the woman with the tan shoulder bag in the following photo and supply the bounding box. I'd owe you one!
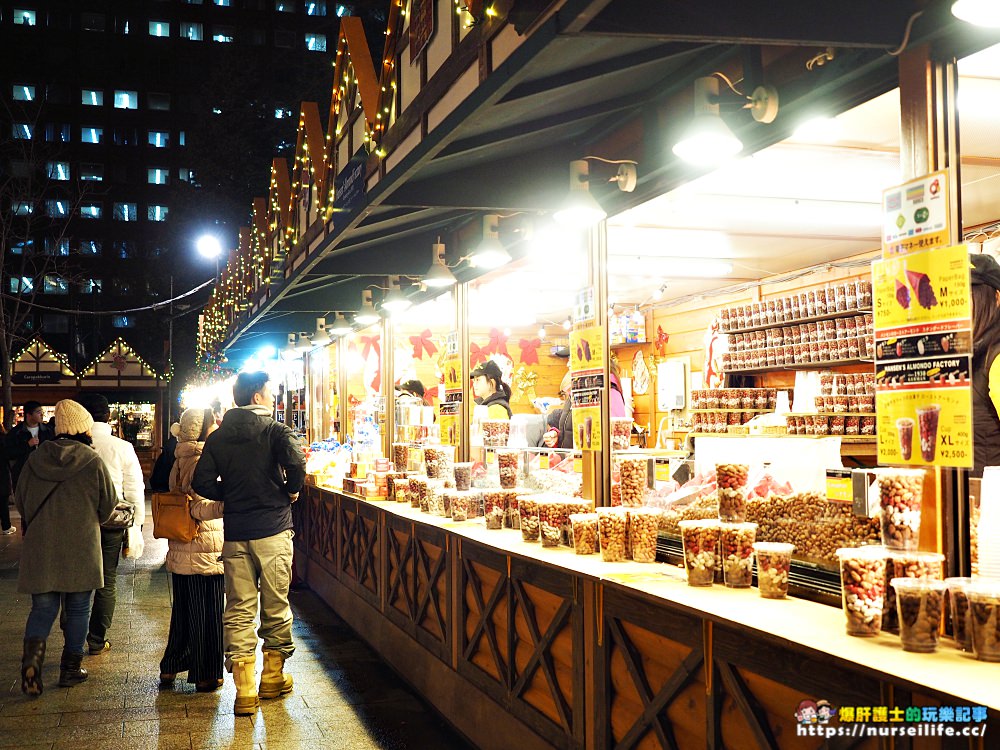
[167,440,223,576]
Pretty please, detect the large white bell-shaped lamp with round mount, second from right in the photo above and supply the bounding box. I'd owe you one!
[673,73,778,166]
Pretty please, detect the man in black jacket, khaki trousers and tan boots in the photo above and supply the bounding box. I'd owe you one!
[191,372,305,716]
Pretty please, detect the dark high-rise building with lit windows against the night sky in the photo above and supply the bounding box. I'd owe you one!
[0,0,347,374]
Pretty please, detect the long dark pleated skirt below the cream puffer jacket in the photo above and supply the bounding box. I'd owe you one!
[160,574,226,682]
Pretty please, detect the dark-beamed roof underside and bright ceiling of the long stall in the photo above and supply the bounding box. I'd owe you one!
[229,0,1000,356]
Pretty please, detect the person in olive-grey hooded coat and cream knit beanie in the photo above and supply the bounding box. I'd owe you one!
[14,399,118,695]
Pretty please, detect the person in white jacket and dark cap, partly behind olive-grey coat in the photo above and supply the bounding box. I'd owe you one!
[77,393,146,656]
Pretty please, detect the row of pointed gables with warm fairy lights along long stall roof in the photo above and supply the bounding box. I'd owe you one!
[197,0,506,378]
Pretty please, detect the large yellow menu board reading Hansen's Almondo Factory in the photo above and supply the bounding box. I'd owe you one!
[872,245,972,468]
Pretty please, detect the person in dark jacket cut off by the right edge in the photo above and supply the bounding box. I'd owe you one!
[969,254,1000,477]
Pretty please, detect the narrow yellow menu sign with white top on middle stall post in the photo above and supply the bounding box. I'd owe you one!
[569,287,605,451]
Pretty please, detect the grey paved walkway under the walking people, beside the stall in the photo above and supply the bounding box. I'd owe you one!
[0,512,469,750]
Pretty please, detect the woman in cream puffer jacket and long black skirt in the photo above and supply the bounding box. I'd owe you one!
[160,409,225,693]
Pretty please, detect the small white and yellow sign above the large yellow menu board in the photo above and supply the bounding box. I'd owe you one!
[882,172,950,258]
